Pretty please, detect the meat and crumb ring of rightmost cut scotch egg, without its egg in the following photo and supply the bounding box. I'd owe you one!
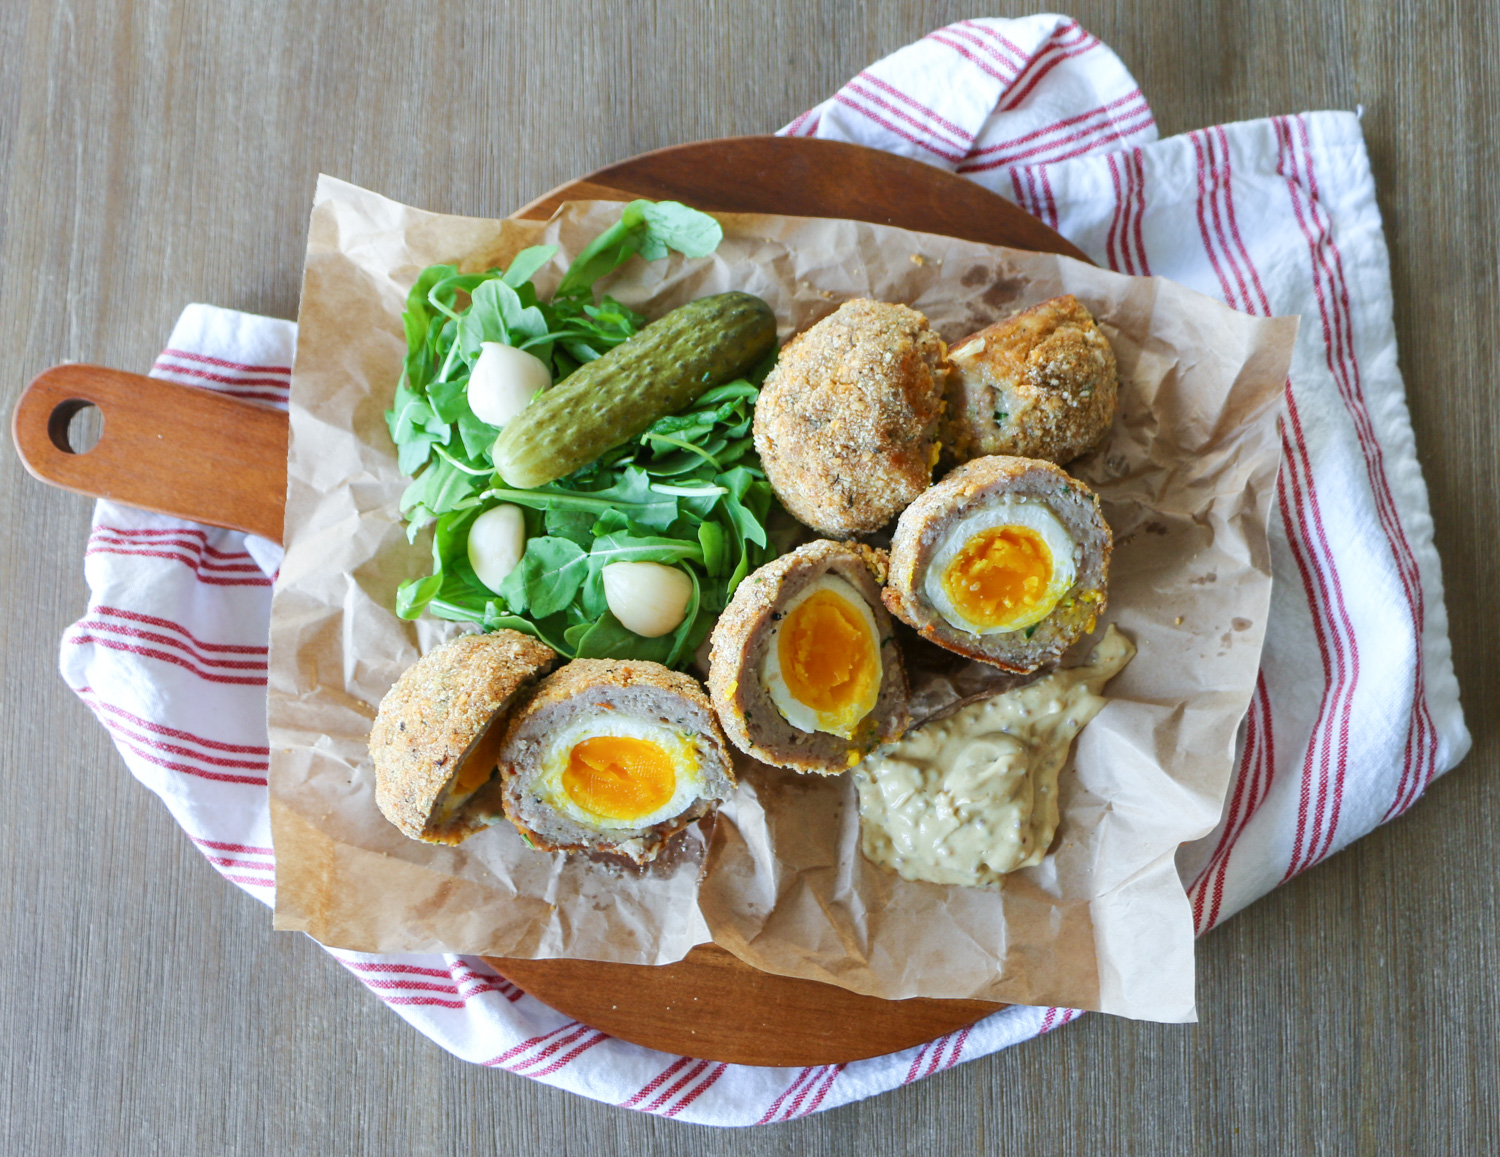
[881,455,1113,674]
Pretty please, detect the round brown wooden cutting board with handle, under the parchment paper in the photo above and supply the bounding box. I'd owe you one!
[12,137,1088,1065]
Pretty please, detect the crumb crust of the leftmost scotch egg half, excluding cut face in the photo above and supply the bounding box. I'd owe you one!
[369,630,558,843]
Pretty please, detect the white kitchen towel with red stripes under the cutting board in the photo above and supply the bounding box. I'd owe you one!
[62,15,1469,1125]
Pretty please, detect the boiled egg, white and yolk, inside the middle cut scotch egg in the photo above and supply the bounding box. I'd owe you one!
[761,575,881,738]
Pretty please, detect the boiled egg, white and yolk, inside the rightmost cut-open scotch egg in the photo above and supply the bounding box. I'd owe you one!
[923,497,1077,635]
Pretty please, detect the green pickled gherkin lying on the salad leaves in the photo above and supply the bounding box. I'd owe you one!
[494,291,776,489]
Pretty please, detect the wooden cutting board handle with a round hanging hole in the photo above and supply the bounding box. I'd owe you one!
[11,363,287,542]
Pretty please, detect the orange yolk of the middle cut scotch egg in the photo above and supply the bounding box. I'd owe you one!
[777,590,881,723]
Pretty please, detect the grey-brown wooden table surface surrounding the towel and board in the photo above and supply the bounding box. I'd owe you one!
[0,0,1500,1155]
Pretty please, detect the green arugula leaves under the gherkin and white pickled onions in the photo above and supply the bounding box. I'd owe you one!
[386,201,780,666]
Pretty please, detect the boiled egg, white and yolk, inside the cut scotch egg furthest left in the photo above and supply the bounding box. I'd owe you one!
[527,711,708,833]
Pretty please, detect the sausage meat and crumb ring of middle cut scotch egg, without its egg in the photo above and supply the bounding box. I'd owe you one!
[708,539,909,774]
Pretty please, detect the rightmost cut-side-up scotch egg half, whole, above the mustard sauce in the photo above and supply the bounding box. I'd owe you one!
[884,455,1113,672]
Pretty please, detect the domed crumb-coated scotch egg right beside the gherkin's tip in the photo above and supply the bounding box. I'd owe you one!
[755,299,948,536]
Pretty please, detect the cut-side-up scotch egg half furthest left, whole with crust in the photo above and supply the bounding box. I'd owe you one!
[500,659,734,863]
